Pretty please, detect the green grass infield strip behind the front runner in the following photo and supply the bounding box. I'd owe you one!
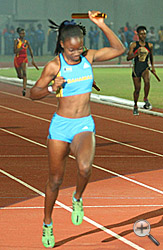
[0,68,163,108]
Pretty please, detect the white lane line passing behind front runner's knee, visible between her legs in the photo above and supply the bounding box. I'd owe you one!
[0,128,163,194]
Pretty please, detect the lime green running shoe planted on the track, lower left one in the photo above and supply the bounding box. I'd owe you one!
[42,224,55,248]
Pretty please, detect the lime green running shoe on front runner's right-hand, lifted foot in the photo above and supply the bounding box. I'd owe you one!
[71,192,84,225]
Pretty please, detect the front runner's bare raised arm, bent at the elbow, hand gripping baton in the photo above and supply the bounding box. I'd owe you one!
[88,11,125,62]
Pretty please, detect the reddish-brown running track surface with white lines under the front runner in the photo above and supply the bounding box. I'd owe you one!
[0,83,163,250]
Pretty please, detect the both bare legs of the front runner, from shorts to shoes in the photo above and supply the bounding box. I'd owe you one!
[44,132,95,224]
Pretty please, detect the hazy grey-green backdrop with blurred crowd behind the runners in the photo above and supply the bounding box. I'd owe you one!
[0,0,163,56]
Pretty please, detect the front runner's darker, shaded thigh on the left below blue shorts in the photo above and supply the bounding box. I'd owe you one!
[47,139,70,177]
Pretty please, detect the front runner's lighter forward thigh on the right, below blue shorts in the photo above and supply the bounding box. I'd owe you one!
[71,131,95,168]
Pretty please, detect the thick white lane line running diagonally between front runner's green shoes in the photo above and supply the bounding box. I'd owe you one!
[0,169,145,250]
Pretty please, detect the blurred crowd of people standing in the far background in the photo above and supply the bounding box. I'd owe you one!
[0,22,163,56]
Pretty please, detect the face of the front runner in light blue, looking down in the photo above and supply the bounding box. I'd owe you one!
[61,37,83,62]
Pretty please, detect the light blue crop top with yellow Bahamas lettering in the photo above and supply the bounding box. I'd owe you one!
[56,53,93,97]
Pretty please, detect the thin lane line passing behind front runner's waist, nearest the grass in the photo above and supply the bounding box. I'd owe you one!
[0,91,163,134]
